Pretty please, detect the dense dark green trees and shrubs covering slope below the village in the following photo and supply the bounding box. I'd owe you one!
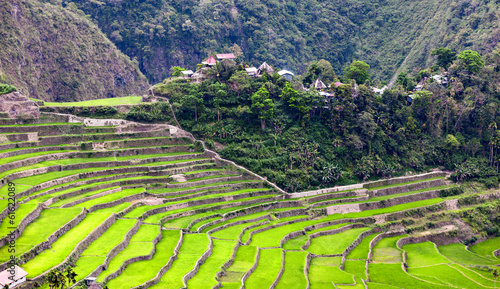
[155,46,500,191]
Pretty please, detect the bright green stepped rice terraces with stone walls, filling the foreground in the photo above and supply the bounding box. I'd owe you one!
[0,113,500,289]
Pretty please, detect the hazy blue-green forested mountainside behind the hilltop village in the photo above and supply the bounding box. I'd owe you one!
[70,0,500,83]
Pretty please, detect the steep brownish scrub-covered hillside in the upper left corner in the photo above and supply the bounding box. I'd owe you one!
[0,0,148,101]
